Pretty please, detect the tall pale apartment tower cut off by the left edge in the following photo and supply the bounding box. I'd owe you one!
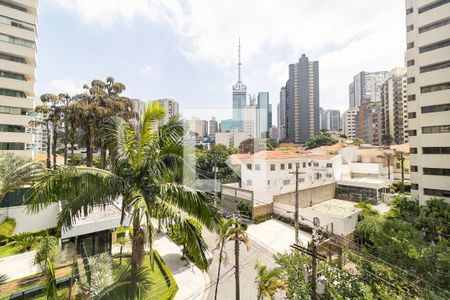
[0,0,38,157]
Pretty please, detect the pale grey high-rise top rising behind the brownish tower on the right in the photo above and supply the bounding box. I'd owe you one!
[349,71,388,107]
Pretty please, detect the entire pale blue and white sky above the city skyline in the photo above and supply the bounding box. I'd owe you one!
[36,0,405,124]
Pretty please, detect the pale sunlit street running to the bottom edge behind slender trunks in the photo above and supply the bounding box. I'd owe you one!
[203,231,276,300]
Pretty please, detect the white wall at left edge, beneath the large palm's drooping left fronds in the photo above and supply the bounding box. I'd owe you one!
[0,203,59,234]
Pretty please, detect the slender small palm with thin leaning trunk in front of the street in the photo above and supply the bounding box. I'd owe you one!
[214,218,249,300]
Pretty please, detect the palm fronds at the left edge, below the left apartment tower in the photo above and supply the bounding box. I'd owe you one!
[0,153,44,201]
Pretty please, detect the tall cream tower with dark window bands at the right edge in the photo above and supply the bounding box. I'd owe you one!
[405,0,450,204]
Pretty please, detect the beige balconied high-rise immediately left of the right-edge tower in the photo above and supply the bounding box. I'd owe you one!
[381,68,408,144]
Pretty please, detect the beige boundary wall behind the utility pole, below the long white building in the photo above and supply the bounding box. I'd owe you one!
[273,183,336,207]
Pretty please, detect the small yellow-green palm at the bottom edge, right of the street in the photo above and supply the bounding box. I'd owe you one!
[255,262,286,300]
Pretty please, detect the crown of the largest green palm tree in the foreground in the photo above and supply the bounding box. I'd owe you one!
[25,103,220,298]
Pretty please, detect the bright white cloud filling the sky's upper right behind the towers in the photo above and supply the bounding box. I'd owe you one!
[54,0,405,116]
